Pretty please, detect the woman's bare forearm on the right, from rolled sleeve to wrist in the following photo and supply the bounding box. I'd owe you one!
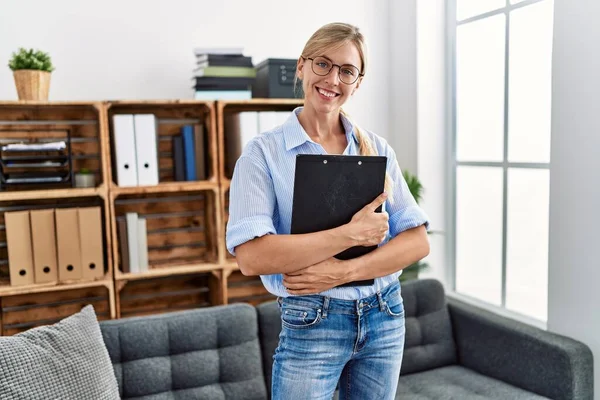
[346,226,429,282]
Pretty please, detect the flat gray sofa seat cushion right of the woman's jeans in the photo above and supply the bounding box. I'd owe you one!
[396,365,547,400]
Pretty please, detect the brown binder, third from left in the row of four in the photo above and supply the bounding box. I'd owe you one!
[54,208,81,282]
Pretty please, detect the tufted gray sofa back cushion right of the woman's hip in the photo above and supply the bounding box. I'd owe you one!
[400,279,457,375]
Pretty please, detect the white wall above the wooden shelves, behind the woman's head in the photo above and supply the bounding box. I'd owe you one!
[0,0,394,143]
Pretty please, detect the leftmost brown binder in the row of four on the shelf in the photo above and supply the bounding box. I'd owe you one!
[4,211,34,286]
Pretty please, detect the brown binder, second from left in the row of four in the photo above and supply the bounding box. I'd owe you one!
[29,210,58,283]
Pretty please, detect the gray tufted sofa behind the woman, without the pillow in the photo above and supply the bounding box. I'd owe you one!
[100,280,593,400]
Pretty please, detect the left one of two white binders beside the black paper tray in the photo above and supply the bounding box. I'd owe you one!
[113,114,137,186]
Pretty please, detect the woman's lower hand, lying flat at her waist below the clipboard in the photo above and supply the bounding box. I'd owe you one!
[283,257,348,295]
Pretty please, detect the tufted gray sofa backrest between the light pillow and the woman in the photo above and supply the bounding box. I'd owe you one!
[100,304,268,400]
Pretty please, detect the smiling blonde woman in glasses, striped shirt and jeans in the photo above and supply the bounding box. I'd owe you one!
[227,23,429,400]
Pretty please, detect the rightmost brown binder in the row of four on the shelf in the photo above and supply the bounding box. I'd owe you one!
[77,207,104,280]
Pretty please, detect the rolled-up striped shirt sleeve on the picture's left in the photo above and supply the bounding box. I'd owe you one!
[225,153,276,256]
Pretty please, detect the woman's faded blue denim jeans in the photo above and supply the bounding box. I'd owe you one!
[272,282,405,400]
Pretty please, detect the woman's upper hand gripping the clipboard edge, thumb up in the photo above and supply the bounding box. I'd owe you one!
[345,193,389,246]
